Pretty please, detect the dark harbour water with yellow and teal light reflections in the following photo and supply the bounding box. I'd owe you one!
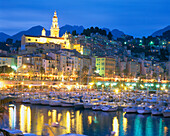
[0,104,170,136]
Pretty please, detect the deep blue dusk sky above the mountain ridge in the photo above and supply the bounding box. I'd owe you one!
[0,0,170,37]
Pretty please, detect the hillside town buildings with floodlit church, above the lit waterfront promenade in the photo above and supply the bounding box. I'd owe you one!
[0,12,170,79]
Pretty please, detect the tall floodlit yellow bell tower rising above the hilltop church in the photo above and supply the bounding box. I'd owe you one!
[50,11,59,37]
